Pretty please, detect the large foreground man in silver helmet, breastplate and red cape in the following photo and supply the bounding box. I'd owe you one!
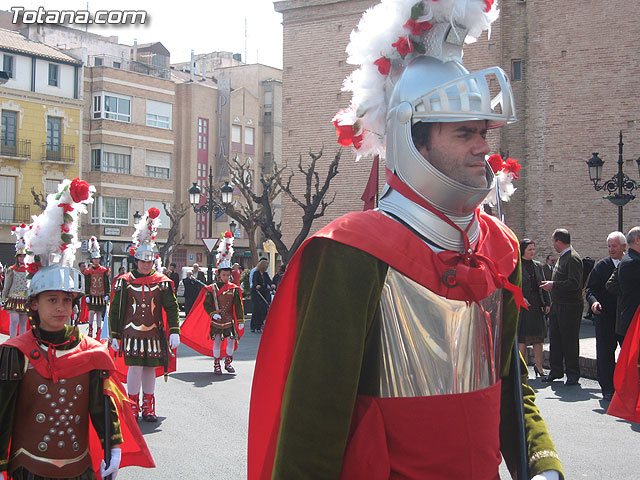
[248,0,562,480]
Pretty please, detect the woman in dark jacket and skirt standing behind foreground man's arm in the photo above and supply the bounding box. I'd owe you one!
[518,238,551,377]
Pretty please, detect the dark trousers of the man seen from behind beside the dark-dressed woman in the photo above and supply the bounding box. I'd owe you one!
[549,303,582,380]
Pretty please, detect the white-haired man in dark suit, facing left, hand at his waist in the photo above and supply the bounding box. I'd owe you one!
[586,232,627,400]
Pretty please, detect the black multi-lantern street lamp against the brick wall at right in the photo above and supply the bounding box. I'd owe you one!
[586,130,640,232]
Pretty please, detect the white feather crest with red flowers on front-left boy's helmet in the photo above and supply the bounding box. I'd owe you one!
[25,179,96,267]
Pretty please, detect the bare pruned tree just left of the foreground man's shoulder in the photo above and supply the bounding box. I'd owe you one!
[222,149,342,263]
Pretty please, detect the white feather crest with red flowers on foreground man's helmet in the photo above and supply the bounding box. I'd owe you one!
[333,0,499,159]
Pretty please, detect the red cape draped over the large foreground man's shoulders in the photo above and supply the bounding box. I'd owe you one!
[247,210,522,480]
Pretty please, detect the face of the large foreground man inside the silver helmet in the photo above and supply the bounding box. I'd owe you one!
[419,120,491,188]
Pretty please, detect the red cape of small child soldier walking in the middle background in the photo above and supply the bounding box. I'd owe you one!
[180,282,244,357]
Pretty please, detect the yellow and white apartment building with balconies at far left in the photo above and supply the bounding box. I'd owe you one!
[0,29,83,264]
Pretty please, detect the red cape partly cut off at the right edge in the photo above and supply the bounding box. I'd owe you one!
[607,308,640,423]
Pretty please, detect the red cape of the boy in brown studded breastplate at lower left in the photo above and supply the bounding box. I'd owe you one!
[3,332,155,478]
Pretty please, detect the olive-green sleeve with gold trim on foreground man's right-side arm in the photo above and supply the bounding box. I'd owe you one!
[500,264,564,478]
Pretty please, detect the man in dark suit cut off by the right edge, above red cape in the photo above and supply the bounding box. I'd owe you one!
[616,227,640,342]
